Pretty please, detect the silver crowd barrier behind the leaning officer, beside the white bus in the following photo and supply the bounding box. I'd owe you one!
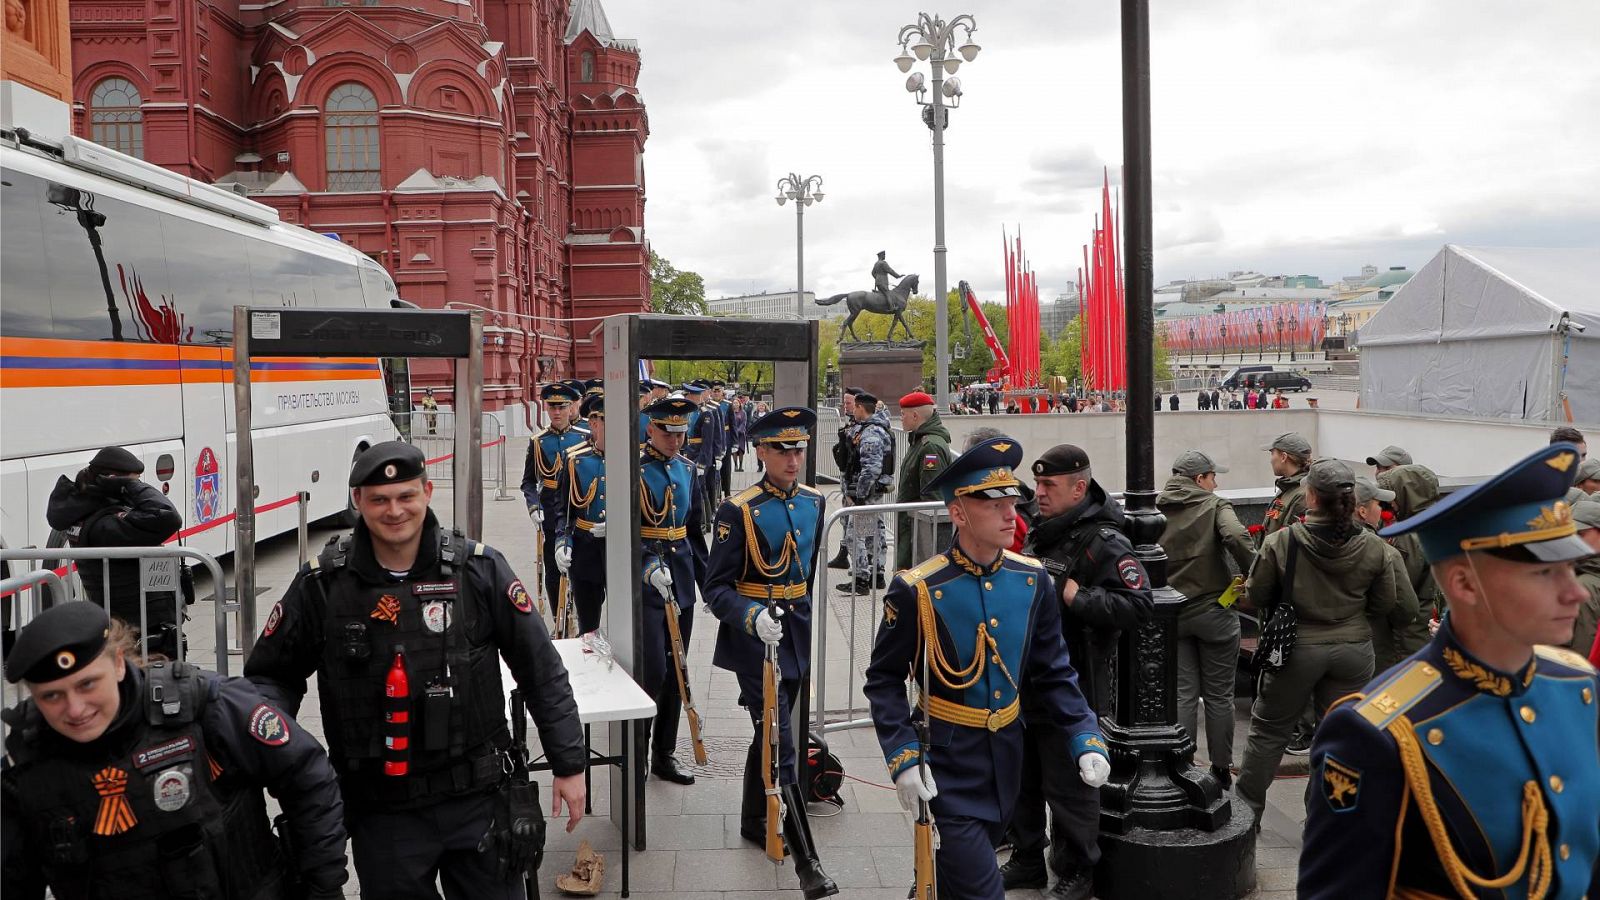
[0,546,232,676]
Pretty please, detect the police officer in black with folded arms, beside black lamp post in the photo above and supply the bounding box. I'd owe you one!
[1002,444,1155,900]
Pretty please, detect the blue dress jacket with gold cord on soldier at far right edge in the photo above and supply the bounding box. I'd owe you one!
[1299,617,1600,900]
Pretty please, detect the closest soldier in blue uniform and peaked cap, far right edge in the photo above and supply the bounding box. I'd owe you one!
[1299,444,1600,900]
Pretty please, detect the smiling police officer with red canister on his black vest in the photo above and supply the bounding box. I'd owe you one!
[245,440,586,900]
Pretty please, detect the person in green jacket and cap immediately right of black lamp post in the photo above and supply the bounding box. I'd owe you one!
[1155,450,1256,788]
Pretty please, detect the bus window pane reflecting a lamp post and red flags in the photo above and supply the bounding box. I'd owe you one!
[36,173,176,344]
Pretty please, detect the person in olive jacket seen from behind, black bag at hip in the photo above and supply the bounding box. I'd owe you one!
[1235,460,1397,822]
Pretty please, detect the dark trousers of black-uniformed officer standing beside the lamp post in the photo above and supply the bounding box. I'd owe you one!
[1011,725,1099,878]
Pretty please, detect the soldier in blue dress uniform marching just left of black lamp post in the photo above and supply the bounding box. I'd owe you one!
[866,437,1110,900]
